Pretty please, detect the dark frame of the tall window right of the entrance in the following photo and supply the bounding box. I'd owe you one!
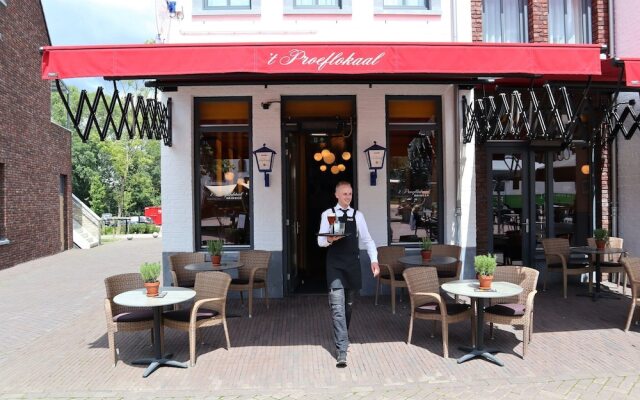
[384,95,446,248]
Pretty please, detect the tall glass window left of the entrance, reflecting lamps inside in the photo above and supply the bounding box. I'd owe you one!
[195,98,252,246]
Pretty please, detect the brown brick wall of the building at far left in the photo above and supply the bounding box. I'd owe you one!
[0,0,73,269]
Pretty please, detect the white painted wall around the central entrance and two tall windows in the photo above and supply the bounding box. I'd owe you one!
[162,84,464,252]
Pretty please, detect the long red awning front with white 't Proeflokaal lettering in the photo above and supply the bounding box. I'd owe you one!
[42,43,601,79]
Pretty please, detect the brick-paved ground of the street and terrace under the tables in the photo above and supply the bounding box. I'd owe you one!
[0,238,640,400]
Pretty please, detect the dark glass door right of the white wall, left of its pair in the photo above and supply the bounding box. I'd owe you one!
[487,147,535,265]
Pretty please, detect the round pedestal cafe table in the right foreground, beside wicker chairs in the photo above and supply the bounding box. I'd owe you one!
[441,279,522,367]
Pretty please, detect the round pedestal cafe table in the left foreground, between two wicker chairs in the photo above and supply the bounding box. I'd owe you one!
[113,287,196,378]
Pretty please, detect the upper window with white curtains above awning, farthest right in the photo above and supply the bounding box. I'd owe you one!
[549,0,591,43]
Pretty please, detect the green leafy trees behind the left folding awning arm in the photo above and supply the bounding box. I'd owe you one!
[51,81,161,217]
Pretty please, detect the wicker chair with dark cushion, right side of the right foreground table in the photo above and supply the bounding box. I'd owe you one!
[484,265,539,358]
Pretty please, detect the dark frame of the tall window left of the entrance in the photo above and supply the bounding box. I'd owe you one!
[191,96,255,251]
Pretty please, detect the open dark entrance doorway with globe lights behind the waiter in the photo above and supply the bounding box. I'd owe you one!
[282,96,357,293]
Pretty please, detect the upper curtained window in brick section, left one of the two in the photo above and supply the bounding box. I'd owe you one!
[482,0,528,43]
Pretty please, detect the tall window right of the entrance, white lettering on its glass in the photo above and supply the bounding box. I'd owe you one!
[387,96,443,243]
